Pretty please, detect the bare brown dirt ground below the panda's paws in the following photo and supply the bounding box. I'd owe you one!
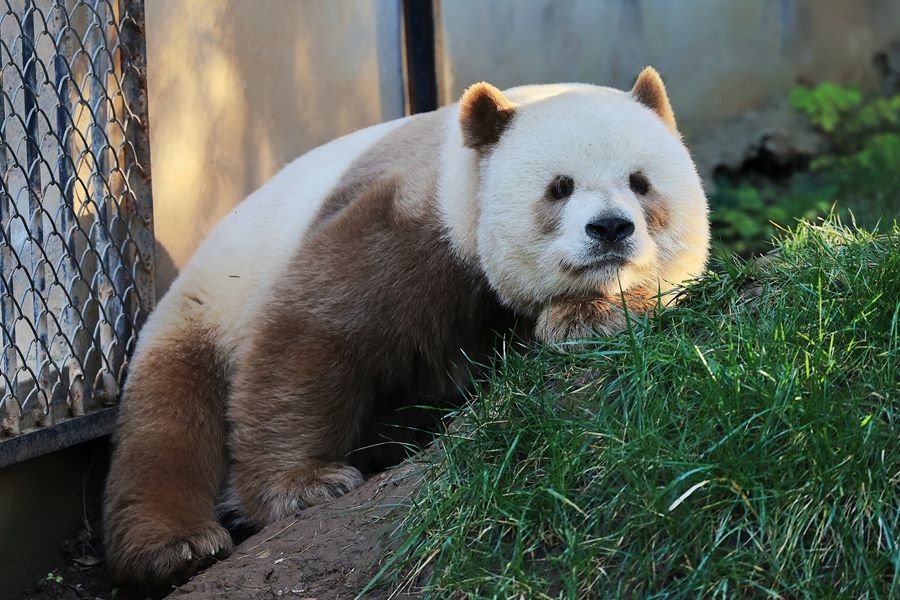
[19,463,419,600]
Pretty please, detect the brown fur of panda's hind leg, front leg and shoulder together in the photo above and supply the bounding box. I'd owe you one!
[105,112,512,584]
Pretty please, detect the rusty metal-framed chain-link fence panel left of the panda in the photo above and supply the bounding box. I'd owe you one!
[0,0,154,465]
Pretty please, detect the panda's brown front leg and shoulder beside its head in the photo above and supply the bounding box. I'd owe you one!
[221,115,511,524]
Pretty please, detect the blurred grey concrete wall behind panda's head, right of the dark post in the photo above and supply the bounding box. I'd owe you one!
[441,0,900,180]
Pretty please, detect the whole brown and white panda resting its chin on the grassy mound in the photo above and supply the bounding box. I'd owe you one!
[104,68,709,585]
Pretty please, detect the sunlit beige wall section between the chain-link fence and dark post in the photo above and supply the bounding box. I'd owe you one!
[145,0,404,295]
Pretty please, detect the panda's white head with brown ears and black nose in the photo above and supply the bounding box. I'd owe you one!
[459,67,709,309]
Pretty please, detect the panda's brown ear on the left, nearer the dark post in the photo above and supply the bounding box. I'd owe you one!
[459,81,516,150]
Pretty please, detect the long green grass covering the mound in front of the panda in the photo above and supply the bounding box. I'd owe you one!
[373,219,900,598]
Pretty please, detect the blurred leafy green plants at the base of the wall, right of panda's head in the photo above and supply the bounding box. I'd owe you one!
[711,83,900,256]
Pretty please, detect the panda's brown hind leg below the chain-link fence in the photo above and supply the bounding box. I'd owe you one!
[104,328,232,585]
